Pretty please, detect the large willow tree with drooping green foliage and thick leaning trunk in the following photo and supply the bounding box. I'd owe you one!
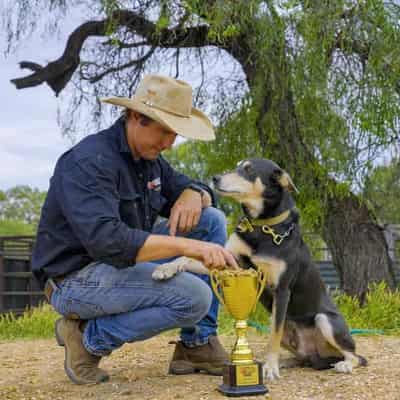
[2,0,400,298]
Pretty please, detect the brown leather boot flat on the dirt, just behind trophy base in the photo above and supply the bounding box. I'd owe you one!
[168,336,229,375]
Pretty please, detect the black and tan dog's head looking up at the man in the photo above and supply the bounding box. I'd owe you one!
[213,158,297,218]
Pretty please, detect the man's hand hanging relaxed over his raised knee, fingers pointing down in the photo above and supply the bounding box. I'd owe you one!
[168,189,203,236]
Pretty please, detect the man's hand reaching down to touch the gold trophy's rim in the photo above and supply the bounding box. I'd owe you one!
[183,240,239,269]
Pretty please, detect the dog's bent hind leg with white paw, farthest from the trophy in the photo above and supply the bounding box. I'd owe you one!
[315,313,366,374]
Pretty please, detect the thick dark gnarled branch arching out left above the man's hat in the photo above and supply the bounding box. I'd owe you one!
[11,10,218,96]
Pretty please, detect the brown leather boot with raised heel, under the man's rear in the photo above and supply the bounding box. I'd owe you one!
[55,318,109,385]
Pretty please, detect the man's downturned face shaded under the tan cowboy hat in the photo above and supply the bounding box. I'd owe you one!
[126,112,177,160]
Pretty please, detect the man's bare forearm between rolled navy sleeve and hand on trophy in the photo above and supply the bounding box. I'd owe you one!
[136,235,191,262]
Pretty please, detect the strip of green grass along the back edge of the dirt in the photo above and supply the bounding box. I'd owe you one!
[0,283,400,341]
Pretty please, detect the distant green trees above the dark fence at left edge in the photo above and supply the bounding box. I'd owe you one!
[0,186,46,230]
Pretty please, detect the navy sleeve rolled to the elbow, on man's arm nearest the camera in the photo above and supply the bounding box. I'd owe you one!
[57,156,150,267]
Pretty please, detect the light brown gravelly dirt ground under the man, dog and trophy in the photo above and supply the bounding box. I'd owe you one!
[0,335,400,400]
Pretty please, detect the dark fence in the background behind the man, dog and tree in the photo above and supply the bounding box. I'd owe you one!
[0,236,400,314]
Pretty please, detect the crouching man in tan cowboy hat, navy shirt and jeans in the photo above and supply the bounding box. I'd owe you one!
[32,75,237,384]
